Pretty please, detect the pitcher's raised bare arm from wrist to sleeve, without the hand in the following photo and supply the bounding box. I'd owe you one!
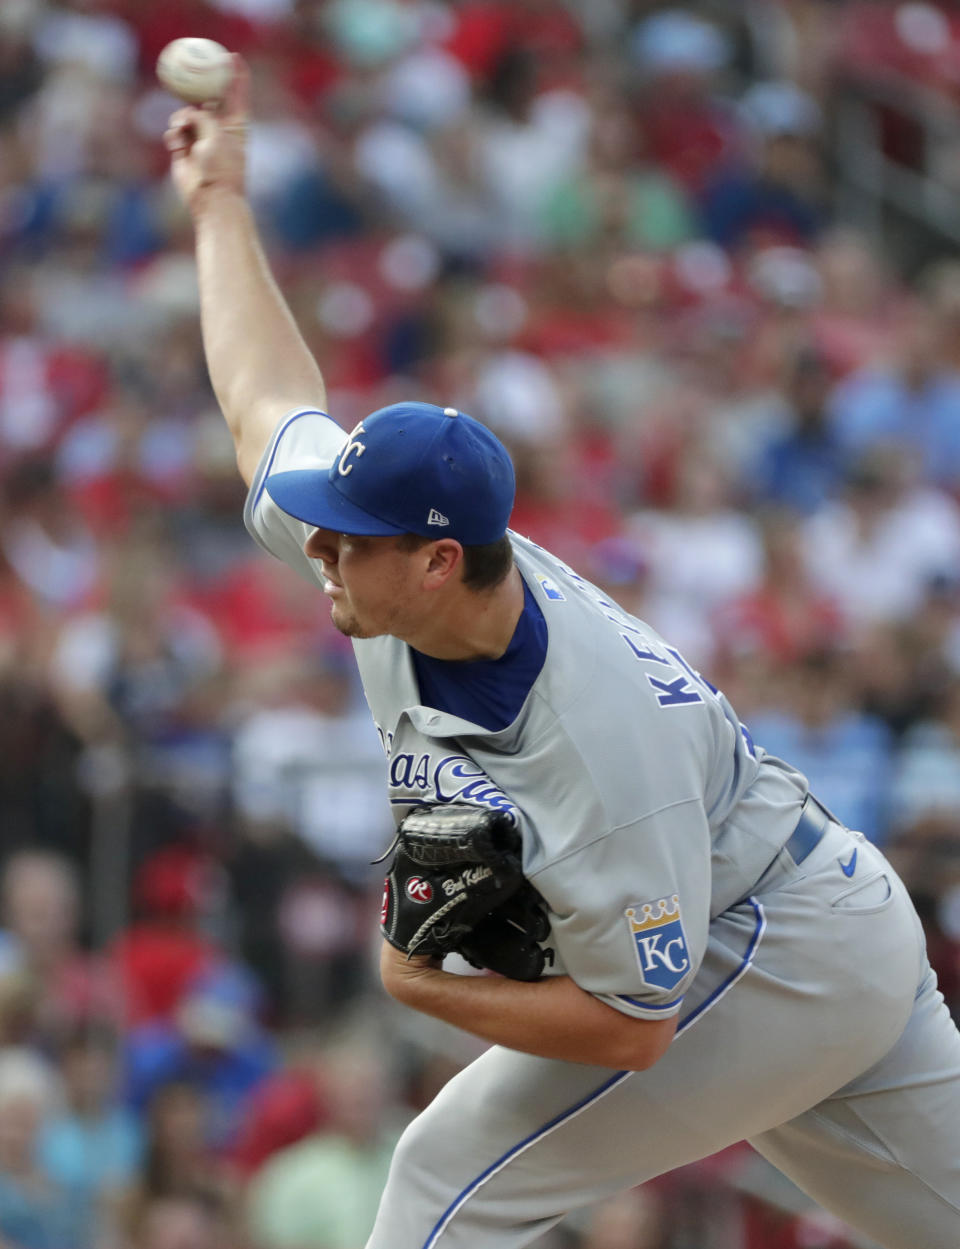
[193,187,326,481]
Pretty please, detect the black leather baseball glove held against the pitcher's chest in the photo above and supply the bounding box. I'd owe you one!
[381,803,549,980]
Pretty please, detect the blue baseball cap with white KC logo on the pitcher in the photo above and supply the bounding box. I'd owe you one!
[267,403,516,546]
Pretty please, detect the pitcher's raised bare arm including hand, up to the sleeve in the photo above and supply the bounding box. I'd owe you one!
[165,56,326,485]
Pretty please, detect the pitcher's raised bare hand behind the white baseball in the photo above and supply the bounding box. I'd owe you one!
[164,56,250,207]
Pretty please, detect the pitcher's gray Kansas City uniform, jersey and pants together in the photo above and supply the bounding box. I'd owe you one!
[246,411,960,1249]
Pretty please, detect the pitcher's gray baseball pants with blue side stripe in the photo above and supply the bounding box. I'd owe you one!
[367,824,960,1249]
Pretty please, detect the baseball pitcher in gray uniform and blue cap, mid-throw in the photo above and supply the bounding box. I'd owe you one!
[167,61,960,1249]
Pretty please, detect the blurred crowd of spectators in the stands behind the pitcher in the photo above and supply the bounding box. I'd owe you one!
[0,0,960,1249]
